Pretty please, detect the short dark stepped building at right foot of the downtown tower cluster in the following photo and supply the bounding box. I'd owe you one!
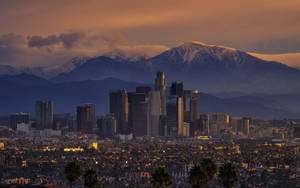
[191,113,210,136]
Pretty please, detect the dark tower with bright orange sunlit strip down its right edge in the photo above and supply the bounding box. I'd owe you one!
[166,96,184,136]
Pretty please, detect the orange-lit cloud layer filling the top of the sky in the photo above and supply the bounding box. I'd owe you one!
[0,0,300,53]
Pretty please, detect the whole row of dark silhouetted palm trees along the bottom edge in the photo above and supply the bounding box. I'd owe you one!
[64,158,238,188]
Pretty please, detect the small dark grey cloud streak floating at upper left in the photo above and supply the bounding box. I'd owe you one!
[27,33,84,49]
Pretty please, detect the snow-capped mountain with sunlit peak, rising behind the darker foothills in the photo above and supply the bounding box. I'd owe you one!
[54,42,300,93]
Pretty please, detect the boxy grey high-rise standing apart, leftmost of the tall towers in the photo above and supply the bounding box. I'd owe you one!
[35,101,53,129]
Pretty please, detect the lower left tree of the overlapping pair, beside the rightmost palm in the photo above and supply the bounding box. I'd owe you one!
[189,164,209,188]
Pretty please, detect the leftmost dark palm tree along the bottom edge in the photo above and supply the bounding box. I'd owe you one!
[64,161,81,188]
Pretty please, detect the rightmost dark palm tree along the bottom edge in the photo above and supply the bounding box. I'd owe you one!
[218,162,238,188]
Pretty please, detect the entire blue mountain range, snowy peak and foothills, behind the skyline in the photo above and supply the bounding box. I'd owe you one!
[0,42,300,118]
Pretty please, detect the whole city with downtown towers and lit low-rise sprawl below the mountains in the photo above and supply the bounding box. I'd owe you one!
[0,72,300,188]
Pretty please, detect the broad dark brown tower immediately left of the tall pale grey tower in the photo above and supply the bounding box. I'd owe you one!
[128,92,148,136]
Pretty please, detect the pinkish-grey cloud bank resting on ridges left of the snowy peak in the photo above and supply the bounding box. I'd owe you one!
[0,32,168,67]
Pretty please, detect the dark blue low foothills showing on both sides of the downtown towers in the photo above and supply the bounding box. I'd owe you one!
[0,74,300,119]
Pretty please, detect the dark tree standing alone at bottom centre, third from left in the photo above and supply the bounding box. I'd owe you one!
[151,167,172,188]
